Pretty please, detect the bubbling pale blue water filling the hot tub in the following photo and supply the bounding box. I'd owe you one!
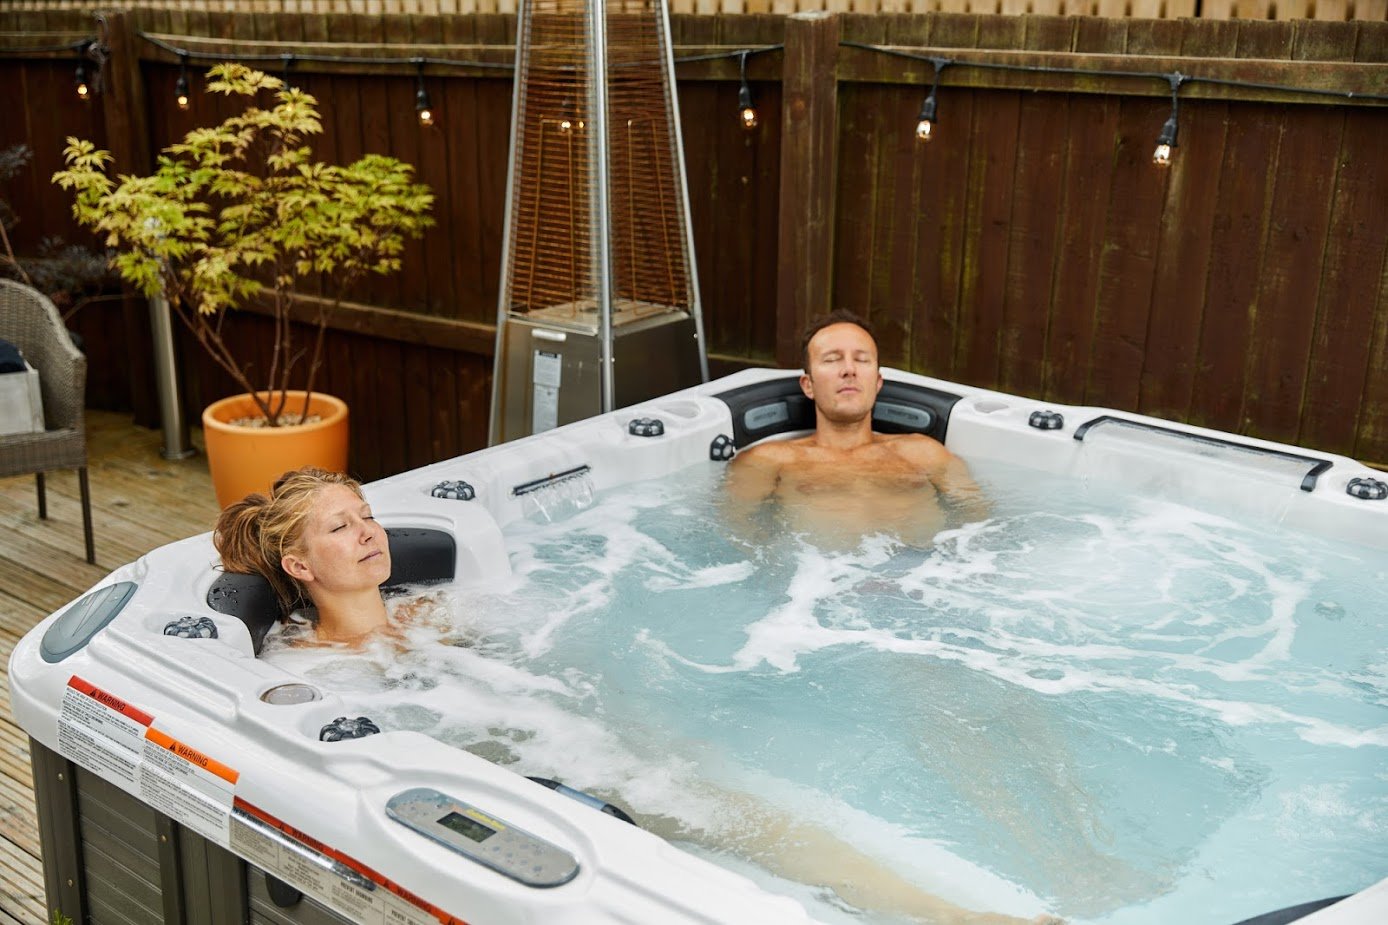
[266,465,1388,925]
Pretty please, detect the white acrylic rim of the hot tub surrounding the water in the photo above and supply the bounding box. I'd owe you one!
[10,369,1388,925]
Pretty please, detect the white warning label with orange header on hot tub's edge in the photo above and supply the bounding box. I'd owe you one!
[137,728,240,847]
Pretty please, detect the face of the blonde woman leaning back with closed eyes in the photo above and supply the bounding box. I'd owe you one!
[280,485,390,597]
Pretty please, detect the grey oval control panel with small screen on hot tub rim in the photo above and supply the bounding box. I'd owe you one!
[386,788,579,886]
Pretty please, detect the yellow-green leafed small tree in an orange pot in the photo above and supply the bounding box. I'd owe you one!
[53,64,433,507]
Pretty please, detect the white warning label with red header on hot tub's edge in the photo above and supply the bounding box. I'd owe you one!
[58,675,154,796]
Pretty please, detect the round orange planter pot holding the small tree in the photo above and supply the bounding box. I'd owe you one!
[203,390,347,507]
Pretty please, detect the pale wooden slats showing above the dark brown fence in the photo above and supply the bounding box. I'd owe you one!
[8,0,1388,22]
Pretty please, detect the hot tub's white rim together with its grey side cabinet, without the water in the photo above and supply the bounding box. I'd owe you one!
[10,371,1388,925]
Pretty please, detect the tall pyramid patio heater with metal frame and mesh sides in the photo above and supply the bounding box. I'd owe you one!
[490,0,708,443]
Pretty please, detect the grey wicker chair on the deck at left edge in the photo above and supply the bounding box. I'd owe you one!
[0,273,96,564]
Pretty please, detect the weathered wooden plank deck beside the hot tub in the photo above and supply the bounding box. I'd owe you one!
[0,411,218,925]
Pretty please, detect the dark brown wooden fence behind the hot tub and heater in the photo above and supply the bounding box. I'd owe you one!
[0,10,1388,478]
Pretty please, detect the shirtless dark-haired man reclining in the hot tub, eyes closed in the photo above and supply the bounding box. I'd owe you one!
[727,310,988,543]
